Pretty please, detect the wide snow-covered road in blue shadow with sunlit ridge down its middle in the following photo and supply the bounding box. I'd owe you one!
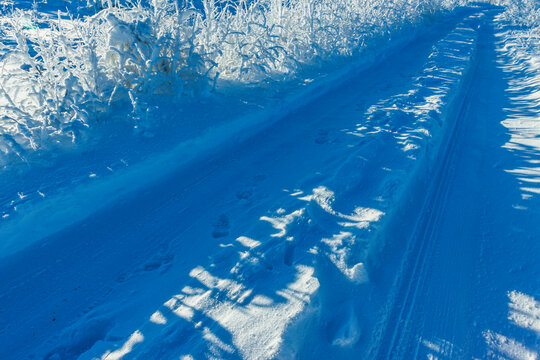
[0,5,540,360]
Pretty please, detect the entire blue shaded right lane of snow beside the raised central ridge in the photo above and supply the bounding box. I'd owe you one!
[375,9,540,359]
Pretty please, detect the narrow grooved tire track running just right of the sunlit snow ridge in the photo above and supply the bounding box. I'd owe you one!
[374,13,486,359]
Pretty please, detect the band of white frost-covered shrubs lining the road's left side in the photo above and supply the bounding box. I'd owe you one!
[0,0,464,162]
